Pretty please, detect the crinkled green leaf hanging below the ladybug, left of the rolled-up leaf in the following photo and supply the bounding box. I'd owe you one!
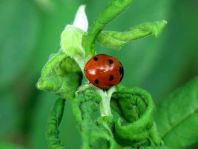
[71,88,116,149]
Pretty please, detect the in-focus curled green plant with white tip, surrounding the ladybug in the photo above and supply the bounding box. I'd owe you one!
[37,0,170,149]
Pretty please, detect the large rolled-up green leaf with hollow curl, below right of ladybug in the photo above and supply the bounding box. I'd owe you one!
[112,87,161,146]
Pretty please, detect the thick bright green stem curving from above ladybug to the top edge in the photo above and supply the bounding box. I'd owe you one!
[84,0,133,58]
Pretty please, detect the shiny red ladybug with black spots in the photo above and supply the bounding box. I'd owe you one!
[84,54,124,90]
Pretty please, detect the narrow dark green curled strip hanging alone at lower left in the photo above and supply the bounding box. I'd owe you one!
[46,99,65,149]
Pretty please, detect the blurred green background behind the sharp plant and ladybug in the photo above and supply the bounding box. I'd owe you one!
[0,0,198,149]
